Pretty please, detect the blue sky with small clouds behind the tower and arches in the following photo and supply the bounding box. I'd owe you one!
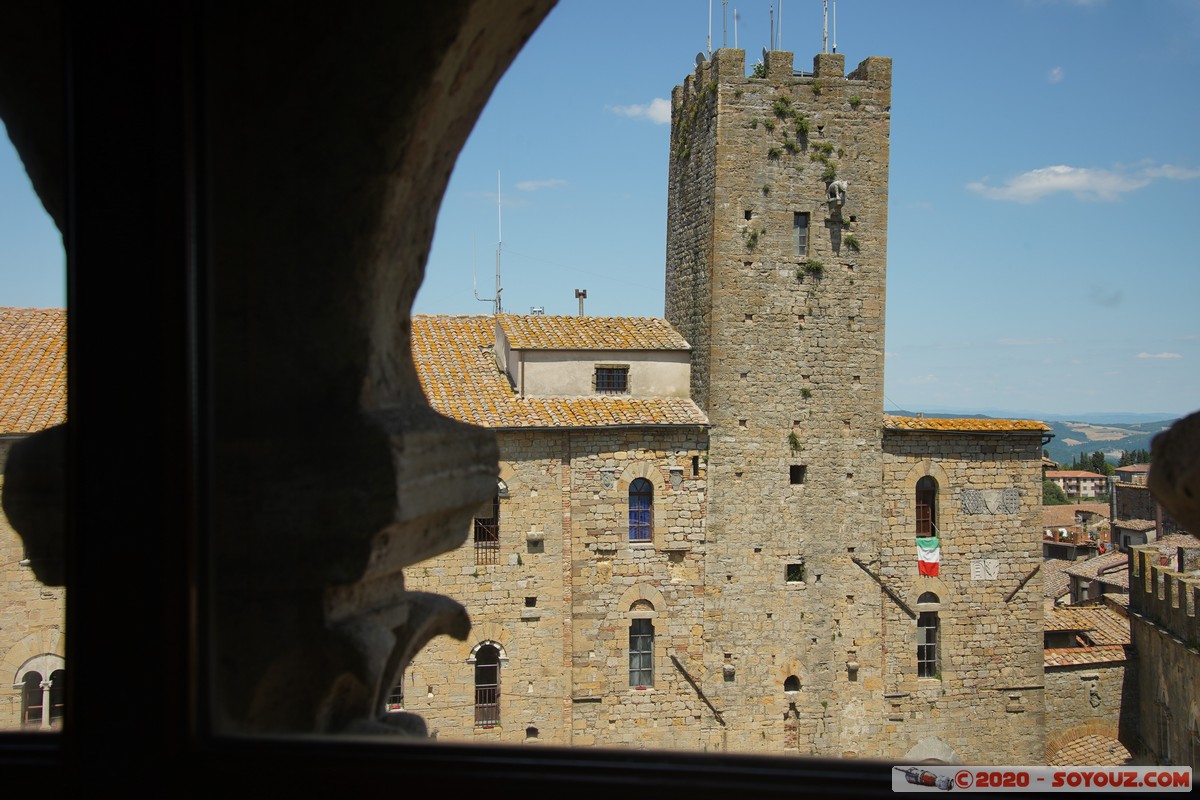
[0,0,1200,414]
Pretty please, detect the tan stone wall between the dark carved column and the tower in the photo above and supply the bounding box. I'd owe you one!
[404,428,719,750]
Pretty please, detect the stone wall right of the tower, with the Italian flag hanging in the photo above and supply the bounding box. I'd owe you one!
[877,431,1044,764]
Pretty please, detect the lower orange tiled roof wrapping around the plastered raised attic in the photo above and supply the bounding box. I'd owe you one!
[413,315,708,428]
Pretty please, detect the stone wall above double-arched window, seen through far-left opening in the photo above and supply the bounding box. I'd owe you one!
[0,439,66,730]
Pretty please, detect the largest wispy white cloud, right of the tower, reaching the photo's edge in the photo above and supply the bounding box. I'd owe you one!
[967,164,1200,203]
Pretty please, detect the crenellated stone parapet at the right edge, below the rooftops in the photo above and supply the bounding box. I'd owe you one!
[1129,545,1200,648]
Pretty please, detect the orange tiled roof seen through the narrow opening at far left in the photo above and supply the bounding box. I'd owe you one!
[0,308,67,434]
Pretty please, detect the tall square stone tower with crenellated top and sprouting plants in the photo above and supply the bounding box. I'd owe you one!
[666,49,892,756]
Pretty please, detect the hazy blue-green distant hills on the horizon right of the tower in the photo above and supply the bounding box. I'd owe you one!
[888,411,1177,464]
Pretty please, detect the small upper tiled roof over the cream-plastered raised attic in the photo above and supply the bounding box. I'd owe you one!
[497,314,691,350]
